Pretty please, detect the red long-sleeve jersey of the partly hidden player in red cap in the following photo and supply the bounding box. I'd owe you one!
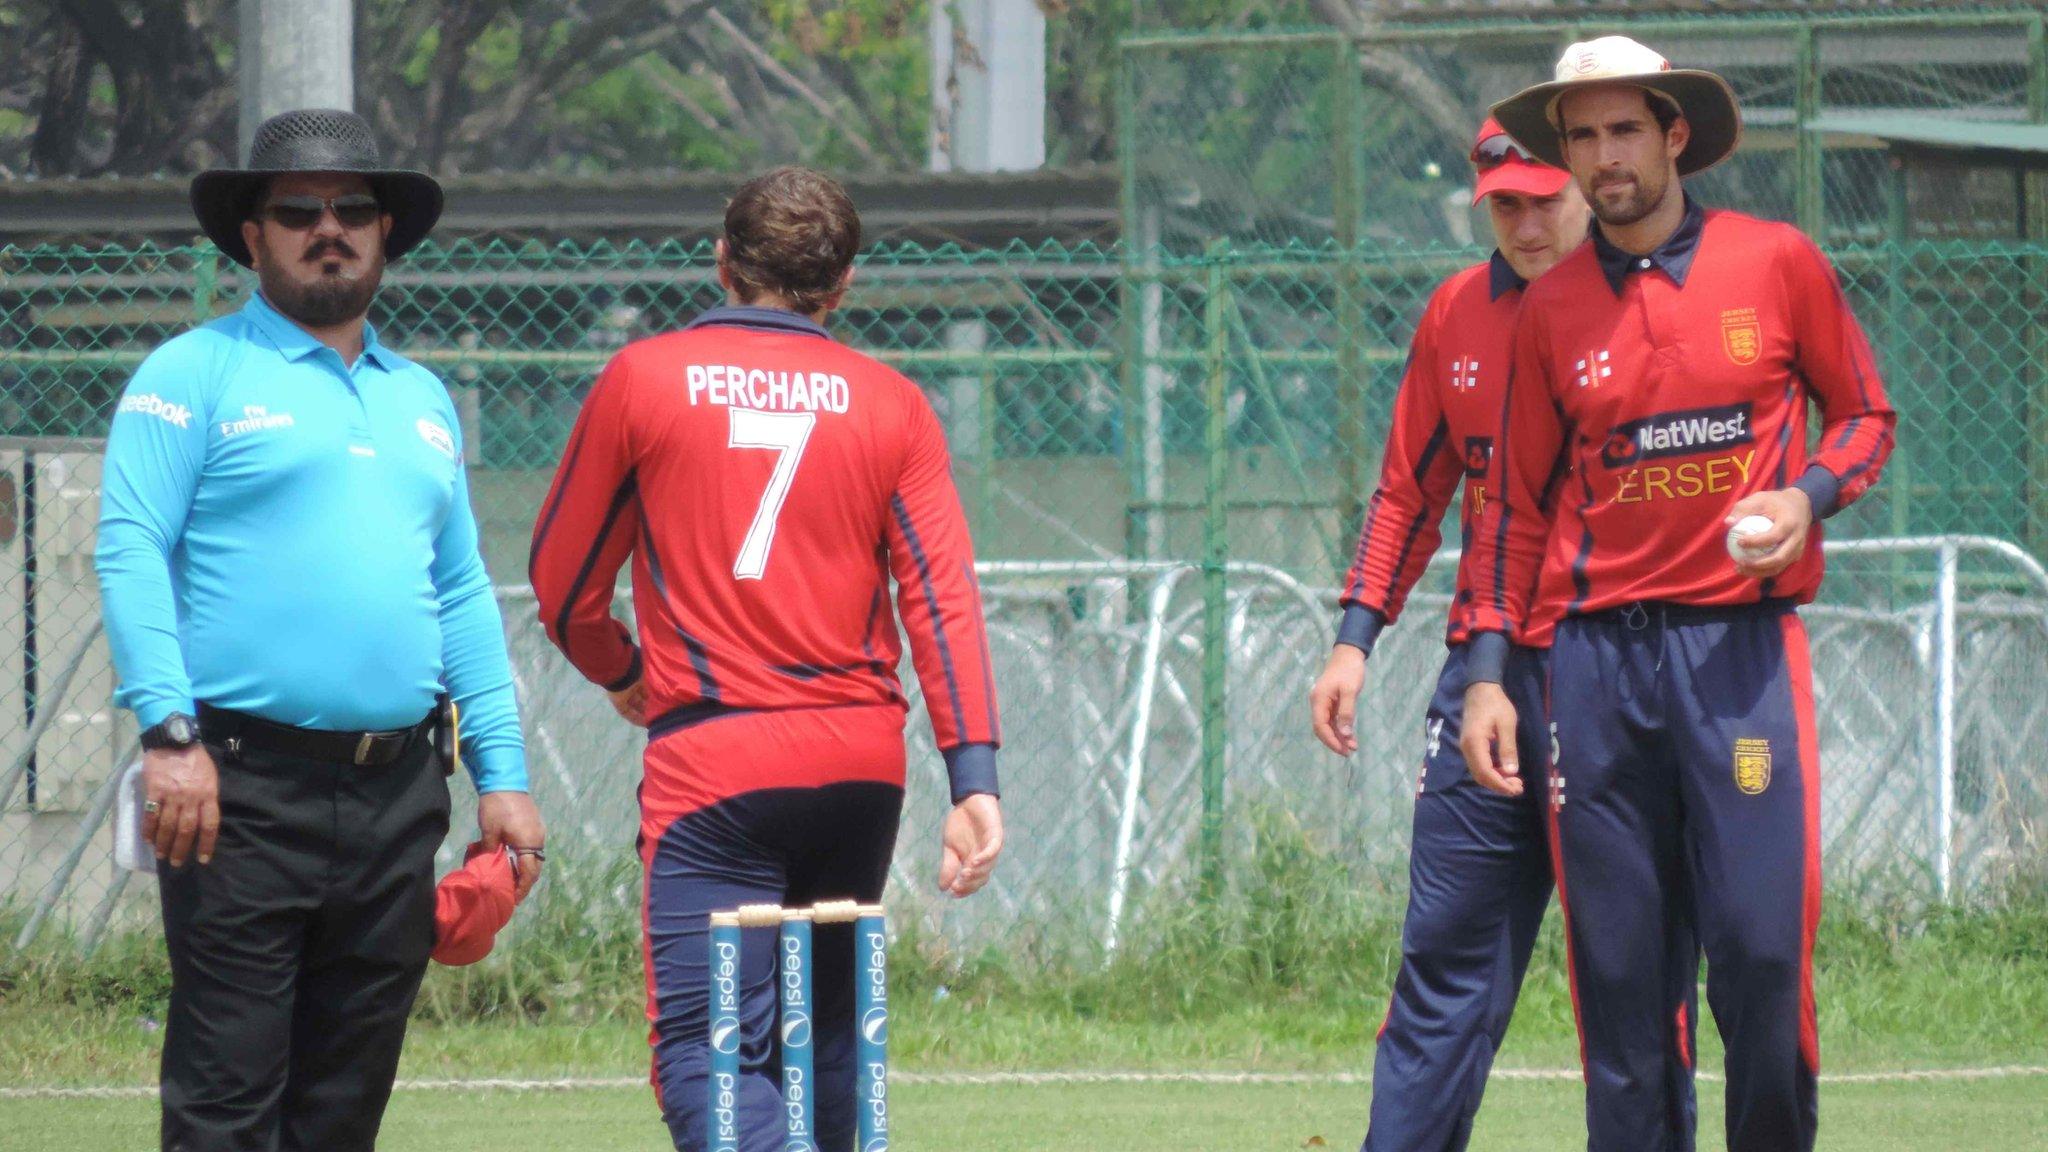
[1339,252,1524,650]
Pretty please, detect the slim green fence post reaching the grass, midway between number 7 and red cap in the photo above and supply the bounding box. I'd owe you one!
[1202,240,1231,898]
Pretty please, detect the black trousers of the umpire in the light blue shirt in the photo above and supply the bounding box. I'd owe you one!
[158,738,449,1152]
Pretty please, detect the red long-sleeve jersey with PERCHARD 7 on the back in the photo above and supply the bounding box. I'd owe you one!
[530,307,999,771]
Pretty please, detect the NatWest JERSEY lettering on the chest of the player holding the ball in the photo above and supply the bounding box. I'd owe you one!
[1599,404,1757,504]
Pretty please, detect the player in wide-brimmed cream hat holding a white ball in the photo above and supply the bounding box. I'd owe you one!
[1464,37,1896,1152]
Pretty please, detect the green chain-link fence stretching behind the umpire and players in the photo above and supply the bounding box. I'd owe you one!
[0,6,2048,947]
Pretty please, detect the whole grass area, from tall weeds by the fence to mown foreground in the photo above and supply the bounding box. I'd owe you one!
[0,828,2048,1152]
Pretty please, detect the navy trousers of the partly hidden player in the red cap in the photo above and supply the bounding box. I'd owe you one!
[1364,646,1692,1152]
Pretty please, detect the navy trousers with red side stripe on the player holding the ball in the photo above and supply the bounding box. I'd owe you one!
[1550,605,1821,1152]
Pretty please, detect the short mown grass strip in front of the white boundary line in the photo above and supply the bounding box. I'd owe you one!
[0,1057,2048,1152]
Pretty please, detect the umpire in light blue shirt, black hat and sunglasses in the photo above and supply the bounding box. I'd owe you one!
[98,111,543,1152]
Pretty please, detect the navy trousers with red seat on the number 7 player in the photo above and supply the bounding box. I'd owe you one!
[639,705,903,1152]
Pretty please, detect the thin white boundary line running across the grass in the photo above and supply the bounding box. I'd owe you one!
[0,1064,2048,1101]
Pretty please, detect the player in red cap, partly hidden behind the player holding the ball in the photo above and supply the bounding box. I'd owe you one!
[1309,119,1692,1152]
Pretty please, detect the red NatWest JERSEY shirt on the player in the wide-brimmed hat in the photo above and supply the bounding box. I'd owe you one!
[1468,201,1896,633]
